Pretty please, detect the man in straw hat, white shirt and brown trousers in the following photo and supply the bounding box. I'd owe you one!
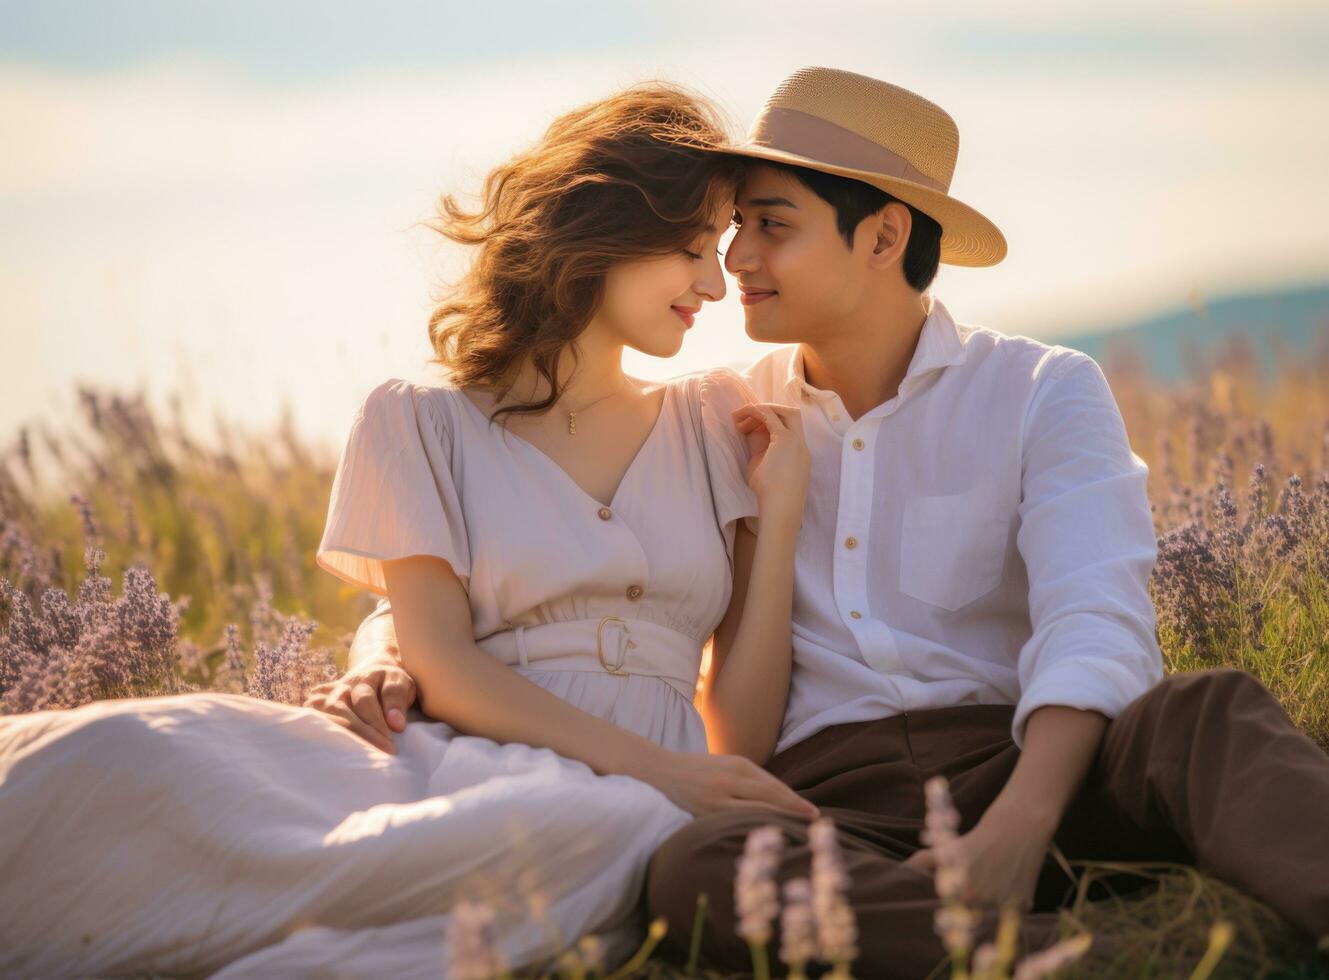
[308,68,1329,977]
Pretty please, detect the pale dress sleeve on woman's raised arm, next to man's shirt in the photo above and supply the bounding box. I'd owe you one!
[700,367,760,557]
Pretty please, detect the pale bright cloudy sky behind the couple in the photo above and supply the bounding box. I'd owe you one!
[0,0,1329,451]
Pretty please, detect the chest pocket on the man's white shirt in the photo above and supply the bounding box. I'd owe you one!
[900,483,1014,610]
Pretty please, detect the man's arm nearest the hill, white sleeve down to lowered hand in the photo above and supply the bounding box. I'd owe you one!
[914,352,1163,902]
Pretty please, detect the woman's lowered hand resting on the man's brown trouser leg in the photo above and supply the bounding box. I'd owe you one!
[633,749,820,820]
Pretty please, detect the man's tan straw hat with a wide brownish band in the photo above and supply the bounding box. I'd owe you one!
[720,68,1006,266]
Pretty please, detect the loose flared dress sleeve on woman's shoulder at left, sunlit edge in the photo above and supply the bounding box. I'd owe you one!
[315,378,470,596]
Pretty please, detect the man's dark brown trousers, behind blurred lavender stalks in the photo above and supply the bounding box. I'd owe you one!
[645,668,1329,977]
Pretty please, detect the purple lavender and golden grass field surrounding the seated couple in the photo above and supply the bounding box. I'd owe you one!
[0,330,1329,977]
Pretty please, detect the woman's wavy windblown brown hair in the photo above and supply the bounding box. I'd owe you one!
[425,82,742,418]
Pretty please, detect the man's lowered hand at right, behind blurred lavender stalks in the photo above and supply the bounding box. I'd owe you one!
[905,800,1057,911]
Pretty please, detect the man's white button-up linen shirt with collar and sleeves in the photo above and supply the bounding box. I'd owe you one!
[743,289,1163,751]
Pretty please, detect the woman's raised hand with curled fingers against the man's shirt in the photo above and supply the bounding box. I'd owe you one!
[732,402,812,527]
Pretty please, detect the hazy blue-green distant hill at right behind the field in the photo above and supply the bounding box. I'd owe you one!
[1049,285,1329,380]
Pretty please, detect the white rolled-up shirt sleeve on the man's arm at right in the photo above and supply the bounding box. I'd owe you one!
[1011,351,1163,747]
